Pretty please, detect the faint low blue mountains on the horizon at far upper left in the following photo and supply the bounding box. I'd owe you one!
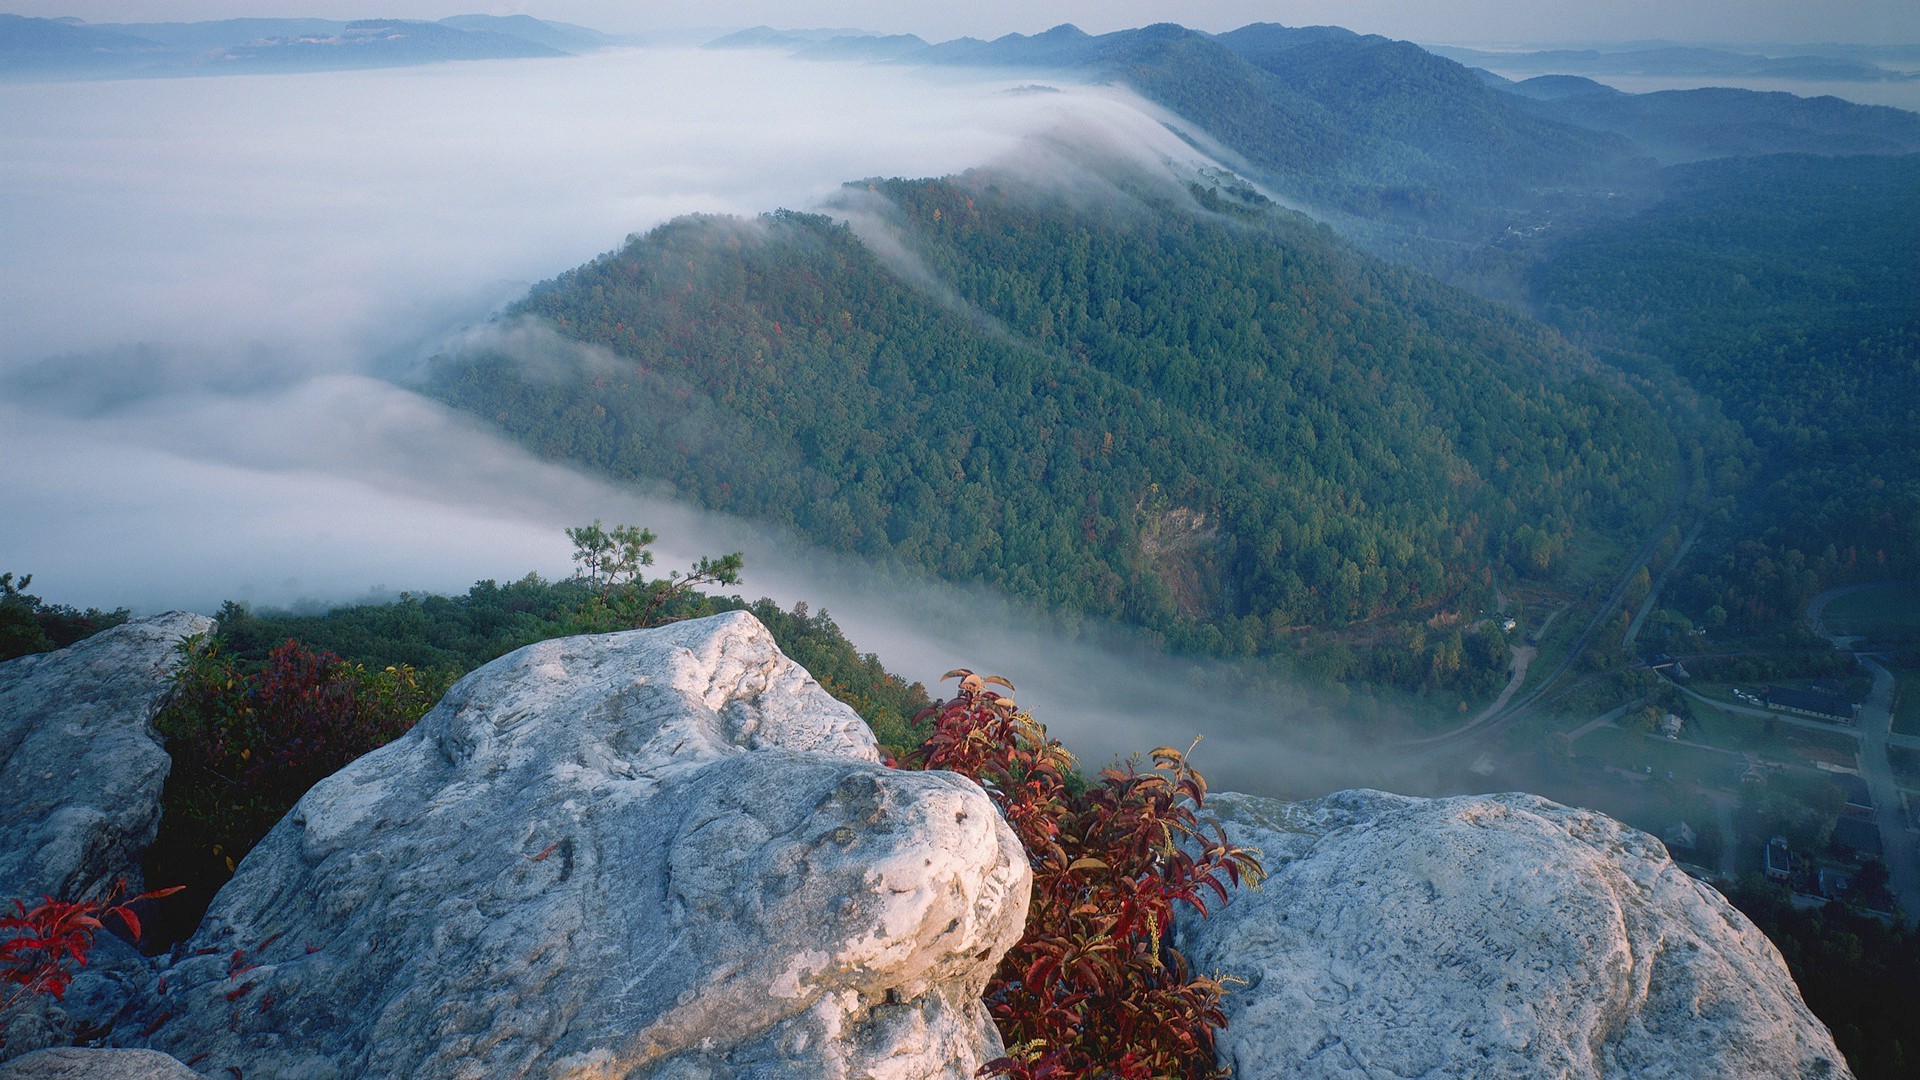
[0,15,616,79]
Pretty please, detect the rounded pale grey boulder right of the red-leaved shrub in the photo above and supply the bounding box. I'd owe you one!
[1179,792,1849,1080]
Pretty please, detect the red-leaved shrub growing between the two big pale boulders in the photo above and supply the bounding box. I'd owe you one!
[899,671,1261,1080]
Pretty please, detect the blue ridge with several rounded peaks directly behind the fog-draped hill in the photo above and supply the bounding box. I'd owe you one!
[900,23,1636,240]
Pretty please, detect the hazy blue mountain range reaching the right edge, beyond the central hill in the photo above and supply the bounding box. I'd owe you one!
[708,23,1920,277]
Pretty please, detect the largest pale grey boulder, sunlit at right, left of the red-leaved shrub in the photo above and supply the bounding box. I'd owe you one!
[115,613,1031,1080]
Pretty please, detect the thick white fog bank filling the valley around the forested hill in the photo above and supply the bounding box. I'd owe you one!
[0,50,1382,790]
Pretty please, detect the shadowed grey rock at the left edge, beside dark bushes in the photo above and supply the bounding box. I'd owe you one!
[0,611,213,899]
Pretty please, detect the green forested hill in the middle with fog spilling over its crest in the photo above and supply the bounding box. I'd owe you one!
[432,175,1676,688]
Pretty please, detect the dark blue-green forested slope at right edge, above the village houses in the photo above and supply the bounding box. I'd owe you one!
[1534,156,1920,623]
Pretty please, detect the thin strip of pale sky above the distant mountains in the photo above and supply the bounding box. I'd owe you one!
[22,0,1920,44]
